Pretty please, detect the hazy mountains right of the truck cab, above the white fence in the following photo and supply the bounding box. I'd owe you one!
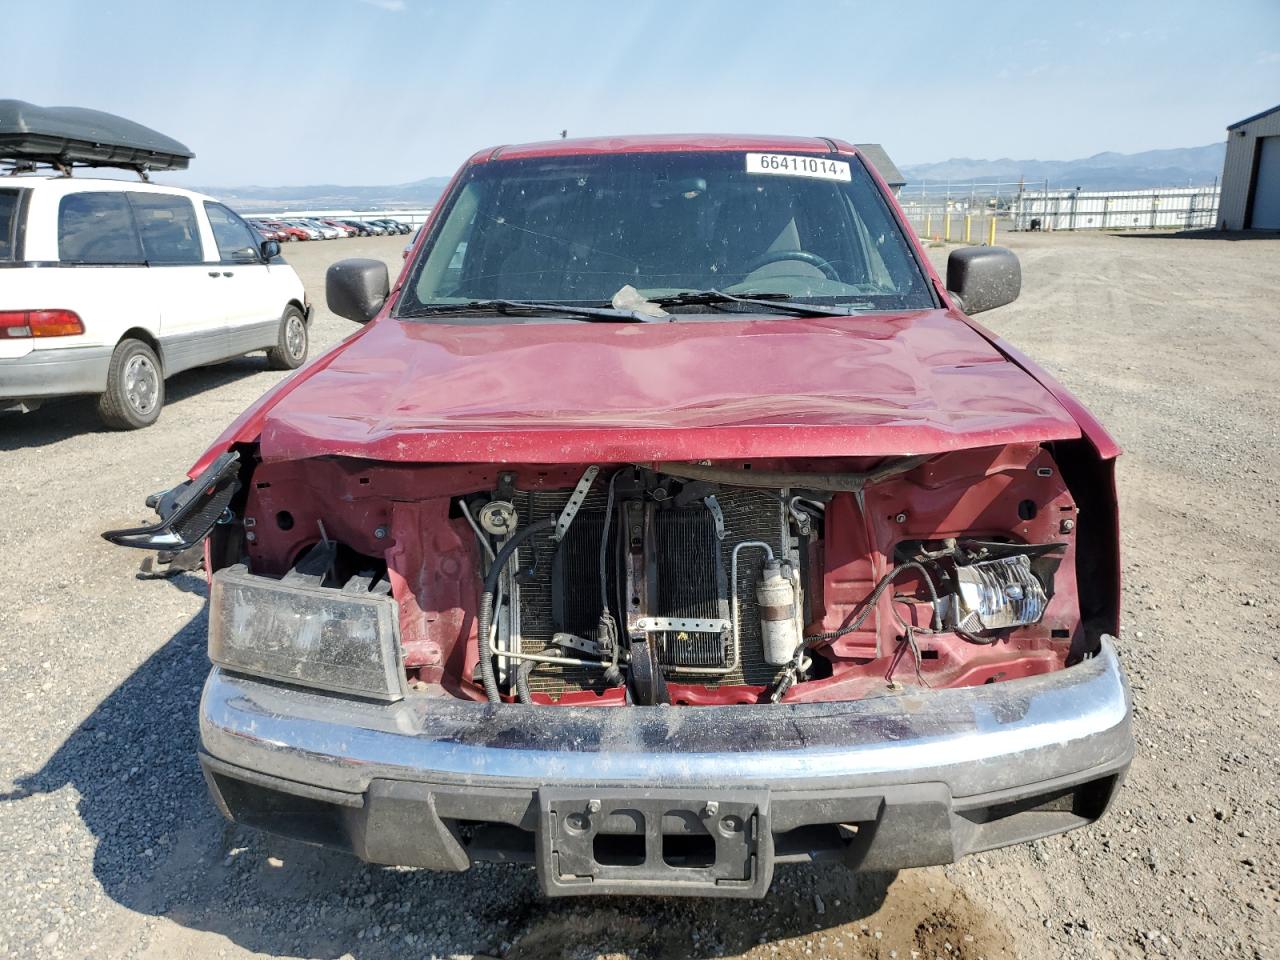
[902,143,1226,193]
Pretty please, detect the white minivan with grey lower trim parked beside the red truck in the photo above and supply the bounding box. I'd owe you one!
[0,175,311,430]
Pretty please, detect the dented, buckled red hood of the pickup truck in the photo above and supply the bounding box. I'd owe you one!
[232,310,1080,463]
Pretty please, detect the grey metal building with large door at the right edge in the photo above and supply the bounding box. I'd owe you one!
[1217,104,1280,230]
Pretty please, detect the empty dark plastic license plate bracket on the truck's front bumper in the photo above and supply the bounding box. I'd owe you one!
[538,787,773,897]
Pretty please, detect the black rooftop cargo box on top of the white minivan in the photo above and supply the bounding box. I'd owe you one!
[0,100,195,173]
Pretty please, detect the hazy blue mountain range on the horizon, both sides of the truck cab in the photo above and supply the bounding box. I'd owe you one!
[185,143,1226,212]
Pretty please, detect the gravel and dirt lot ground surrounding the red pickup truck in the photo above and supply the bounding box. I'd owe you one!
[0,234,1280,960]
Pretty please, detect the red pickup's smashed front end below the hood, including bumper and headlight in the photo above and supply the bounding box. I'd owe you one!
[104,424,1133,897]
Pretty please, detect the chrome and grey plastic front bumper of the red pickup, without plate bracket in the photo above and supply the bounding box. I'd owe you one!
[200,639,1133,896]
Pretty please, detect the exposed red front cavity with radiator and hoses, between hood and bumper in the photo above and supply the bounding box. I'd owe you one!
[222,444,1105,705]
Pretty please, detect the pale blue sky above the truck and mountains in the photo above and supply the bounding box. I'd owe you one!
[10,0,1280,186]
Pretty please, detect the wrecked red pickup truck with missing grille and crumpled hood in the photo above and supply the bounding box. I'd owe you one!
[106,136,1133,896]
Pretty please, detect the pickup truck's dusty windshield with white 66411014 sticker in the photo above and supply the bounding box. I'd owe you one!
[399,151,934,316]
